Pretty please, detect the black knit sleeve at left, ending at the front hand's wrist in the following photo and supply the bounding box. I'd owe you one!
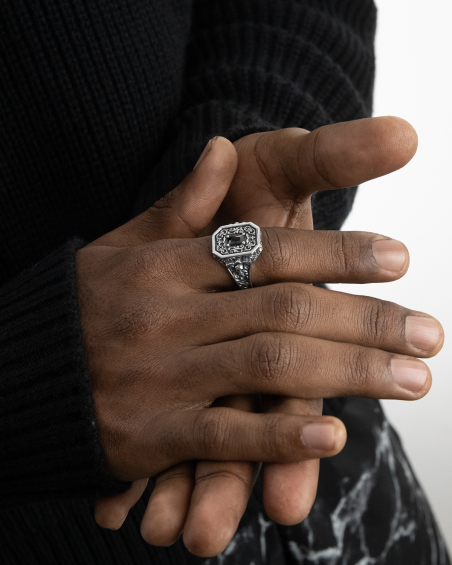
[0,240,129,506]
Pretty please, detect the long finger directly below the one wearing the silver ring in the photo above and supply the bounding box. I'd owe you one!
[181,283,444,357]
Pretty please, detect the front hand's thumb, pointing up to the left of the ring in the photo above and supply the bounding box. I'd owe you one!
[96,137,238,247]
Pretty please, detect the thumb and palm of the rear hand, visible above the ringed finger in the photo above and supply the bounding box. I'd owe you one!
[217,117,418,231]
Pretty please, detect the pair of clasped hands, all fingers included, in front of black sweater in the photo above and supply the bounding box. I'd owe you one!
[77,118,443,557]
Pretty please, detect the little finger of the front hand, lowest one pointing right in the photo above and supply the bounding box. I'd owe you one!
[131,407,345,480]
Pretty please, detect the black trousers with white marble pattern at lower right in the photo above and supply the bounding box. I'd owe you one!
[200,398,450,565]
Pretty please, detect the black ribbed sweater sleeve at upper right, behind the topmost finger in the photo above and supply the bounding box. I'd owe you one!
[134,0,376,229]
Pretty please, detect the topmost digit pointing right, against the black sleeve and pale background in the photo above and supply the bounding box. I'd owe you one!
[266,116,418,198]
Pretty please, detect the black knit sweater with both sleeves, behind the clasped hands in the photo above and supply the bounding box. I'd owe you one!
[0,0,375,563]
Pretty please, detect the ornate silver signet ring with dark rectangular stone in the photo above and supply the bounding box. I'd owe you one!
[212,222,262,289]
